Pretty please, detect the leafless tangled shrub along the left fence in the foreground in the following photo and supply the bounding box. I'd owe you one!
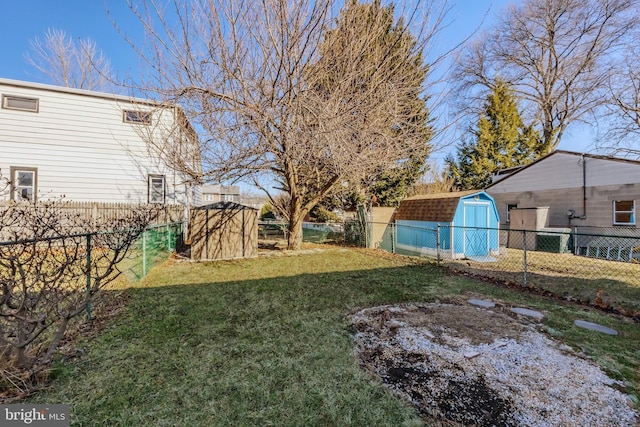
[0,200,157,391]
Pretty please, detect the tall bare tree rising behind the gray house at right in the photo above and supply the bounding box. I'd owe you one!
[457,0,638,152]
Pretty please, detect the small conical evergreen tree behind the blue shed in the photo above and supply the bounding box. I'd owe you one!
[446,81,544,190]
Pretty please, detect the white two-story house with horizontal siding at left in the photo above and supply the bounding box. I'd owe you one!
[0,79,200,206]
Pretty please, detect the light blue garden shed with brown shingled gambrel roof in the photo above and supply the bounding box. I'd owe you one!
[395,190,499,260]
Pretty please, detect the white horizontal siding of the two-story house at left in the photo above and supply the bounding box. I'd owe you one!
[0,79,194,204]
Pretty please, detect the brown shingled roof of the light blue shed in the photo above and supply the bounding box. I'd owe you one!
[395,190,481,222]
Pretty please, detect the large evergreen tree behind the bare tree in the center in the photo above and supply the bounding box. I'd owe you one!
[314,0,433,209]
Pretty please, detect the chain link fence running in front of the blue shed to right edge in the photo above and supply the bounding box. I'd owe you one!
[367,223,640,317]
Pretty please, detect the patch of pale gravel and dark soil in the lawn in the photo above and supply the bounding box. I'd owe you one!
[350,304,639,427]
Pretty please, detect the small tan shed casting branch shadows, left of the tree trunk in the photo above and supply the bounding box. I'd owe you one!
[190,202,258,261]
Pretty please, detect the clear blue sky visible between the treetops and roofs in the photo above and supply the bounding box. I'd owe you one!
[0,0,592,157]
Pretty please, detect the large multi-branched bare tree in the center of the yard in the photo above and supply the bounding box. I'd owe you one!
[121,0,445,249]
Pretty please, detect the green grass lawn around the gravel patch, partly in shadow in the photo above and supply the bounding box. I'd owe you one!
[30,246,640,427]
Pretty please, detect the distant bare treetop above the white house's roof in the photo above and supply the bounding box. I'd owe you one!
[25,28,113,91]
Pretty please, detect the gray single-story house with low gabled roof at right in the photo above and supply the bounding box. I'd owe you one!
[486,150,640,231]
